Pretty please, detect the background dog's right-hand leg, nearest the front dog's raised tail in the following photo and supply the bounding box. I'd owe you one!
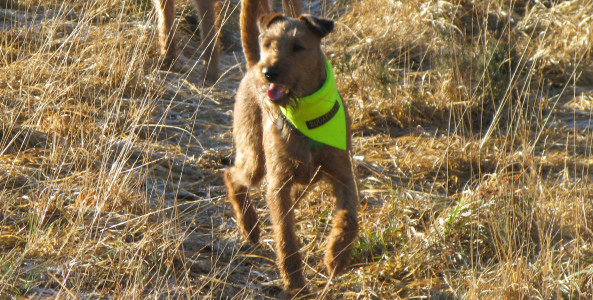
[194,0,220,82]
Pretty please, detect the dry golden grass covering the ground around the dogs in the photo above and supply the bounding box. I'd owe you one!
[0,0,593,299]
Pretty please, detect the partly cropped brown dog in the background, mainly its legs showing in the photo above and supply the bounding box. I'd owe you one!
[153,0,303,82]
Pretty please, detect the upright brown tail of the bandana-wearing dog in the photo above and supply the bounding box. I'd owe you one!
[240,0,270,68]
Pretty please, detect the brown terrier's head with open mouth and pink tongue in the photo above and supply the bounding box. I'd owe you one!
[256,14,334,106]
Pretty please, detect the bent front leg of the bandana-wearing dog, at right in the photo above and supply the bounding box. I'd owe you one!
[325,152,358,274]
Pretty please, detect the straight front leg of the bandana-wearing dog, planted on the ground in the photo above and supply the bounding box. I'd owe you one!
[266,175,305,297]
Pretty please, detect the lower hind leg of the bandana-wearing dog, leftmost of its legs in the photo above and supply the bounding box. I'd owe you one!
[224,167,260,244]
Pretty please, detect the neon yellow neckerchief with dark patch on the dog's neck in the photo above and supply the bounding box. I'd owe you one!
[280,59,347,150]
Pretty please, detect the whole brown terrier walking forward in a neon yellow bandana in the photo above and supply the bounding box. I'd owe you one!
[224,0,358,297]
